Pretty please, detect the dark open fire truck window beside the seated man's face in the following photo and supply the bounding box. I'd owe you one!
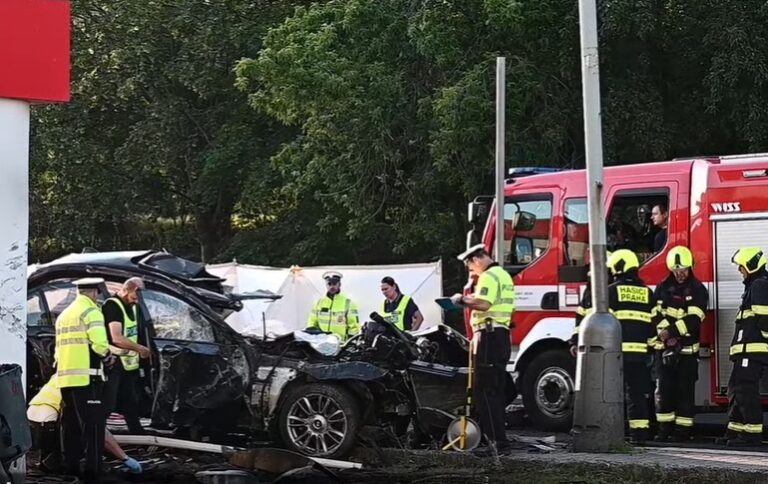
[606,193,669,264]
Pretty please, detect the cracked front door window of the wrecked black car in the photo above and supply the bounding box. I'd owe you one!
[141,289,215,343]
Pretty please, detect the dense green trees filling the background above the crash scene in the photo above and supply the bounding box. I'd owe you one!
[31,0,768,285]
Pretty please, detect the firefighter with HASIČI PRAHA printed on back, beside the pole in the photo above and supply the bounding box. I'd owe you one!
[608,249,655,444]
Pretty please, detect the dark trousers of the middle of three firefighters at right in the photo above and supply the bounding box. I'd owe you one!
[656,354,699,431]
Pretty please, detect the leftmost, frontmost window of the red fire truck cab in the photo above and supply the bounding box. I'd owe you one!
[504,200,552,266]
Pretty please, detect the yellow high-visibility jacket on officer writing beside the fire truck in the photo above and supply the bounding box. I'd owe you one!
[472,265,515,330]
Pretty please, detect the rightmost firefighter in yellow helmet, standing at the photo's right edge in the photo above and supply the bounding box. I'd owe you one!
[726,247,768,447]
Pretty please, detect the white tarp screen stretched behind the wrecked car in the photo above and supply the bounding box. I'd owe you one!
[206,261,443,336]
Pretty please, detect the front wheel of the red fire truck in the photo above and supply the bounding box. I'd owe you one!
[522,348,576,432]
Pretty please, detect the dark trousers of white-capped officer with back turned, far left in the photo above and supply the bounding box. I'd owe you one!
[61,377,106,482]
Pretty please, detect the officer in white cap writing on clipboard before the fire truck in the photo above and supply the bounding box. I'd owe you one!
[451,245,515,450]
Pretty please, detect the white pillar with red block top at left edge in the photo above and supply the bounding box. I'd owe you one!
[0,0,70,483]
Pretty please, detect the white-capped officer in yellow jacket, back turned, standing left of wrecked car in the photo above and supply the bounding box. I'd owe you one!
[54,277,114,482]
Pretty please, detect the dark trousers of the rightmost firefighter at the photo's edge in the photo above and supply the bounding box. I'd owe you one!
[727,358,763,441]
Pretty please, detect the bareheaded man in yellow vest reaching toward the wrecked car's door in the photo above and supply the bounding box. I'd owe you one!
[101,277,149,435]
